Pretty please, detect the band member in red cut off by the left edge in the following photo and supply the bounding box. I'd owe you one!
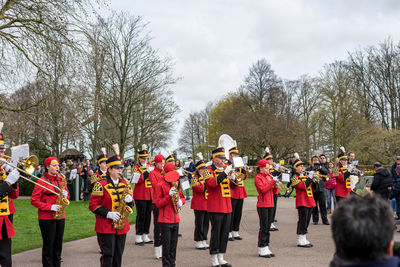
[0,126,19,267]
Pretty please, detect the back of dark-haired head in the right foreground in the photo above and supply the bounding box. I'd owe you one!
[332,194,394,262]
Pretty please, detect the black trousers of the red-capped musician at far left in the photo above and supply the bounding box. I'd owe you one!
[39,219,65,267]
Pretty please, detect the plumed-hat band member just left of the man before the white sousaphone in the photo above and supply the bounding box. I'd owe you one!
[190,152,210,249]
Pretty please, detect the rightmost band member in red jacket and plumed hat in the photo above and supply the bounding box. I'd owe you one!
[335,147,351,203]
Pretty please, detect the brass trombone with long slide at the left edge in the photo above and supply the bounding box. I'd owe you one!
[3,155,62,195]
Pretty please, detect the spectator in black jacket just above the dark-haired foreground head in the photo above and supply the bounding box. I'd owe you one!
[371,162,392,200]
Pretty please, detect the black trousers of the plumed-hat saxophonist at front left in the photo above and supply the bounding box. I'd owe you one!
[97,233,126,267]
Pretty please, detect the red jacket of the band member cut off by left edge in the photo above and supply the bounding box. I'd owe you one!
[0,168,19,239]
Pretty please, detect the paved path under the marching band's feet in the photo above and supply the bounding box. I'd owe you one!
[13,197,399,267]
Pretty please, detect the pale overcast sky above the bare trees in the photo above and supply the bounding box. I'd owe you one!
[111,0,400,155]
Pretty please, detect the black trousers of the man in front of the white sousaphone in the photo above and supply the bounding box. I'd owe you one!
[208,212,232,255]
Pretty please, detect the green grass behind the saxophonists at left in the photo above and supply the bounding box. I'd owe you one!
[12,199,136,253]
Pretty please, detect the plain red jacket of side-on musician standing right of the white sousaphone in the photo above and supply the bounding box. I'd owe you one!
[254,173,276,208]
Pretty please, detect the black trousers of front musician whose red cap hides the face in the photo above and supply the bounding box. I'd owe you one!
[160,223,179,267]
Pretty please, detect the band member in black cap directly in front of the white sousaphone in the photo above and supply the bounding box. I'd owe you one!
[204,147,236,267]
